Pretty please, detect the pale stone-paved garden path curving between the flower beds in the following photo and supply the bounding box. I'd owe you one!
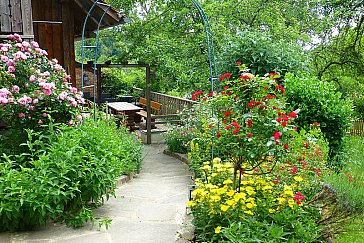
[0,144,191,243]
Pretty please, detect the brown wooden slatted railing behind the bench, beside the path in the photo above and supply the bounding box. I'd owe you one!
[133,88,197,115]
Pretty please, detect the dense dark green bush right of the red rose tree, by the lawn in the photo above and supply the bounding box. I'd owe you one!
[285,74,352,167]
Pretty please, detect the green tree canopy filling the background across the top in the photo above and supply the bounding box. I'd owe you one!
[76,0,364,98]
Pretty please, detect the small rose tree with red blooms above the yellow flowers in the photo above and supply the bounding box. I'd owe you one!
[199,64,298,183]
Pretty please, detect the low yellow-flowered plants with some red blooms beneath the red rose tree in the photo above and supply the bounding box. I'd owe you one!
[188,130,325,242]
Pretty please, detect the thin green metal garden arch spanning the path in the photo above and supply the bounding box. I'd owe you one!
[81,0,218,157]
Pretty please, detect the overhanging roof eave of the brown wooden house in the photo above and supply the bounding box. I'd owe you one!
[73,0,125,37]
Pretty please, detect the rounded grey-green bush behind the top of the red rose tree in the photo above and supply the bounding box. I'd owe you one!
[220,31,309,76]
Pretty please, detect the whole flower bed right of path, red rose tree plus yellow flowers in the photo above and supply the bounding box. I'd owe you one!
[183,64,328,242]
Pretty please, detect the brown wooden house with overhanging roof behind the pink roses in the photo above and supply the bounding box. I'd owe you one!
[0,0,124,85]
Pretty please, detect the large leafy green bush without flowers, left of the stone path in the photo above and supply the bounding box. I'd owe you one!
[0,119,141,230]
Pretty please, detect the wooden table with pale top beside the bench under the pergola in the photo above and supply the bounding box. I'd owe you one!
[107,102,143,129]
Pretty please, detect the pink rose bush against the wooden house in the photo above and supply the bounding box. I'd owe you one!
[0,34,85,130]
